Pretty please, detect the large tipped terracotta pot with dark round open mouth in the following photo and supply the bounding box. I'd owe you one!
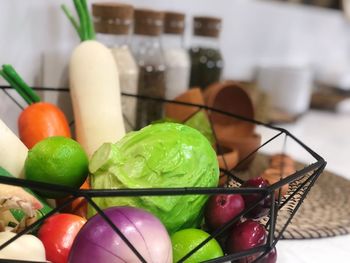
[204,81,255,137]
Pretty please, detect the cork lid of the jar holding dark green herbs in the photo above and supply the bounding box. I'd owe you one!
[193,16,221,37]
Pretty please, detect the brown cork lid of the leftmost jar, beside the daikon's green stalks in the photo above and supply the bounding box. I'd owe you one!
[92,3,134,35]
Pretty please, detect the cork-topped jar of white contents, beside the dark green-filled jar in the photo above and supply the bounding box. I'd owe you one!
[162,12,190,100]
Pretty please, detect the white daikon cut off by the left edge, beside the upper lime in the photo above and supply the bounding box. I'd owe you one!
[0,119,28,178]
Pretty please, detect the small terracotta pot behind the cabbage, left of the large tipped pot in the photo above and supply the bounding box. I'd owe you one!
[165,88,205,122]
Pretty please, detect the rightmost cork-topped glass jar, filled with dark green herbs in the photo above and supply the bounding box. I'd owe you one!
[189,17,223,89]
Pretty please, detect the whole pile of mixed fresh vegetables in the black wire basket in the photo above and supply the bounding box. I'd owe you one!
[0,0,276,263]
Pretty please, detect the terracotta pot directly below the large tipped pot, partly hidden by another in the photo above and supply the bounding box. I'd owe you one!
[219,133,261,170]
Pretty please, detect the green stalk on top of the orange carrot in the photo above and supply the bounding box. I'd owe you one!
[0,64,41,105]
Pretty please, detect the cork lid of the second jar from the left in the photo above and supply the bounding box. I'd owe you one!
[134,9,164,36]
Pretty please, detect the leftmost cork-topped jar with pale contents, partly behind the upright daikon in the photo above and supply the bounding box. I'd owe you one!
[92,3,138,131]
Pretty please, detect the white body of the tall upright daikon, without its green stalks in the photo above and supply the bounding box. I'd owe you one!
[69,40,125,156]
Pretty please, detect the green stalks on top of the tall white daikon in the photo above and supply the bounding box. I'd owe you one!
[61,0,95,41]
